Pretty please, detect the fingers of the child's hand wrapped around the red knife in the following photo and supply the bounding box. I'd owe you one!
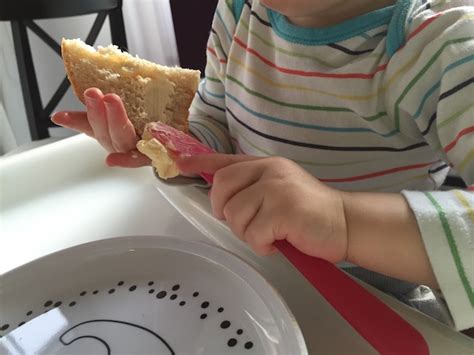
[176,154,277,256]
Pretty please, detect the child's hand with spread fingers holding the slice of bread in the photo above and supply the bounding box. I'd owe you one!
[52,88,150,168]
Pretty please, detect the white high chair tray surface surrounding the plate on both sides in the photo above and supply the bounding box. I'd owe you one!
[0,135,474,355]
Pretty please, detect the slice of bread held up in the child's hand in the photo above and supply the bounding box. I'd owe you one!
[61,39,200,136]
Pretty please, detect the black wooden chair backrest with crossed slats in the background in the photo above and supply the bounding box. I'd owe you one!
[0,0,127,140]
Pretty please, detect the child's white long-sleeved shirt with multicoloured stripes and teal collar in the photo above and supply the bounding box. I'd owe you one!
[190,0,474,329]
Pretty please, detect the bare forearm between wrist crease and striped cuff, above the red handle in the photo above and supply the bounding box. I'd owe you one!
[343,192,438,288]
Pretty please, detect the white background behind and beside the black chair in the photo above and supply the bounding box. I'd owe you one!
[0,0,179,154]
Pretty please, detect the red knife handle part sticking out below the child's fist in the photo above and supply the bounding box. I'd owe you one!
[275,241,430,355]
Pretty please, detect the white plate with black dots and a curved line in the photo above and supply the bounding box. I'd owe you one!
[0,237,307,355]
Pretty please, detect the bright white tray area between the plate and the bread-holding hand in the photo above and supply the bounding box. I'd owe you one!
[0,135,200,275]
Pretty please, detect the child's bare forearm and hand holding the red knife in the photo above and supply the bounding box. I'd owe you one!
[178,154,437,288]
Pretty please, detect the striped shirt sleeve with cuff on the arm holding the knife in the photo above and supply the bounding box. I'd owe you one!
[386,1,474,329]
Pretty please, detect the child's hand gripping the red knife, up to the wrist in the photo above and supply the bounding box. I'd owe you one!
[177,154,348,262]
